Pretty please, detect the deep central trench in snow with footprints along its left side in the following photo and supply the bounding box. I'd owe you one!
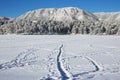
[41,45,73,80]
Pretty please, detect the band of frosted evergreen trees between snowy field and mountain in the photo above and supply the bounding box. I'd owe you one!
[0,20,120,35]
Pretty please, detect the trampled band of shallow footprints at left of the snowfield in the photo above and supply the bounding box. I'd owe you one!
[0,49,37,69]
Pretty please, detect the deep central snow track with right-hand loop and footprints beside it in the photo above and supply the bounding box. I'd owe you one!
[45,45,102,80]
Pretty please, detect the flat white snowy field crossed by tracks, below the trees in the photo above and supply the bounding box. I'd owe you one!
[0,35,120,80]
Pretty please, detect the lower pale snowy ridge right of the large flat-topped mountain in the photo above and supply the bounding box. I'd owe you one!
[94,12,120,22]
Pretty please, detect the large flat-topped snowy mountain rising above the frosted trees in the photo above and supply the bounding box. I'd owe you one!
[17,7,98,22]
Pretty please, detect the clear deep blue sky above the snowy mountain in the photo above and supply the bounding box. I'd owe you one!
[0,0,120,18]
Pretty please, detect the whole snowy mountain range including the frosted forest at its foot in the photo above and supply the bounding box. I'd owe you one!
[0,7,120,35]
